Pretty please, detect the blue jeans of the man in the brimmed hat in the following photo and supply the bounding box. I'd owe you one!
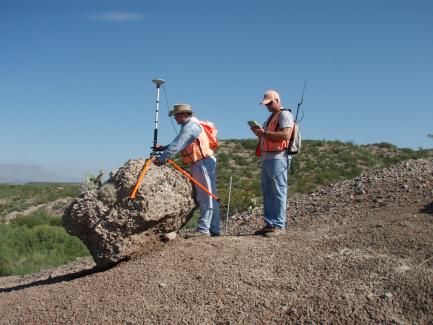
[191,157,221,234]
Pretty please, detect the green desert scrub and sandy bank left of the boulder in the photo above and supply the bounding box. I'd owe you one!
[0,183,88,276]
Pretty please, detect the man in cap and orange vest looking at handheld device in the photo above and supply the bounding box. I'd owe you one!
[251,90,294,237]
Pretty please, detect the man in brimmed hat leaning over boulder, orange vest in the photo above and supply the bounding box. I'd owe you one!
[152,104,221,237]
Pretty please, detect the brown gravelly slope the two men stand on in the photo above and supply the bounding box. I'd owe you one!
[0,159,433,324]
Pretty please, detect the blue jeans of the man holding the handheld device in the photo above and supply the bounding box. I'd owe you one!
[262,159,290,229]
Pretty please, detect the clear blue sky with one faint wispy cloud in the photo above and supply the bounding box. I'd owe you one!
[0,0,433,179]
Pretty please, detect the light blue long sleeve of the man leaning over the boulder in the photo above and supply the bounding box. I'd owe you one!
[158,118,201,163]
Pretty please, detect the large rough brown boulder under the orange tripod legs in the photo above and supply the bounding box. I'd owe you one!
[62,159,196,267]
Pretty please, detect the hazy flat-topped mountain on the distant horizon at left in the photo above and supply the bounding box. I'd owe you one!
[0,164,74,184]
